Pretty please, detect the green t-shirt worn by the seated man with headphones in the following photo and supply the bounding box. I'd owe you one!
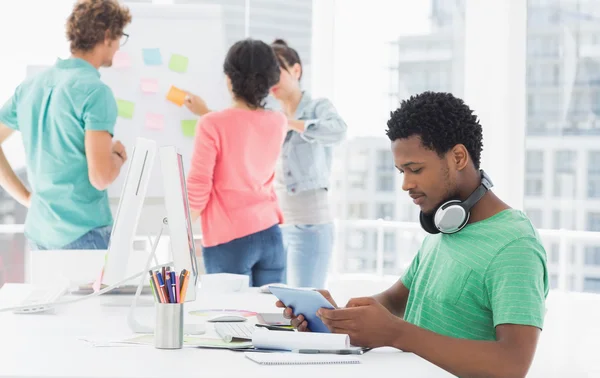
[401,209,548,340]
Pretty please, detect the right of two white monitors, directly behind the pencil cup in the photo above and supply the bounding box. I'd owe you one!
[159,146,198,302]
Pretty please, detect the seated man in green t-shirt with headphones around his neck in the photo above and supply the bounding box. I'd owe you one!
[277,92,548,377]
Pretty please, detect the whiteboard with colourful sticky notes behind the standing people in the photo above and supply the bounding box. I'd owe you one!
[100,3,231,198]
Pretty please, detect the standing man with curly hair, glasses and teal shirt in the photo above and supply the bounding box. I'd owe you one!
[0,0,131,249]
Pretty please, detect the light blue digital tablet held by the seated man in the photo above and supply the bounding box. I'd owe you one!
[269,286,335,333]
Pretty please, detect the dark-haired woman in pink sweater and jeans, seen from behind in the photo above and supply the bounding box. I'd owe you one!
[187,39,287,286]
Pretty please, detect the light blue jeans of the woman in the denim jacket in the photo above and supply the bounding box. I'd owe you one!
[281,223,334,289]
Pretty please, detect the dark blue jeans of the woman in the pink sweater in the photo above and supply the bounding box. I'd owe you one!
[202,224,286,286]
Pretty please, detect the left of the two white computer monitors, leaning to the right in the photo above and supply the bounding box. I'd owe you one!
[94,138,157,291]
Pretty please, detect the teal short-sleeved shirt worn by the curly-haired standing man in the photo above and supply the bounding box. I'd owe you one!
[0,58,117,248]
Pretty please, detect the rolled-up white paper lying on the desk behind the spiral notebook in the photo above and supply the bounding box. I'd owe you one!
[252,329,351,350]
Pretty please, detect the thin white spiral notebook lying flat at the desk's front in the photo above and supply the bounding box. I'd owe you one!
[244,352,360,365]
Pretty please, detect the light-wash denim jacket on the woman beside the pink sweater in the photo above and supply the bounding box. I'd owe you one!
[281,92,347,195]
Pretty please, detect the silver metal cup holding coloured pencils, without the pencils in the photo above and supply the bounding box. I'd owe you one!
[154,303,183,349]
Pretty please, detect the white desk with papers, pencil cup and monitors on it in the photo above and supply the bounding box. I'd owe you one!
[0,284,600,378]
